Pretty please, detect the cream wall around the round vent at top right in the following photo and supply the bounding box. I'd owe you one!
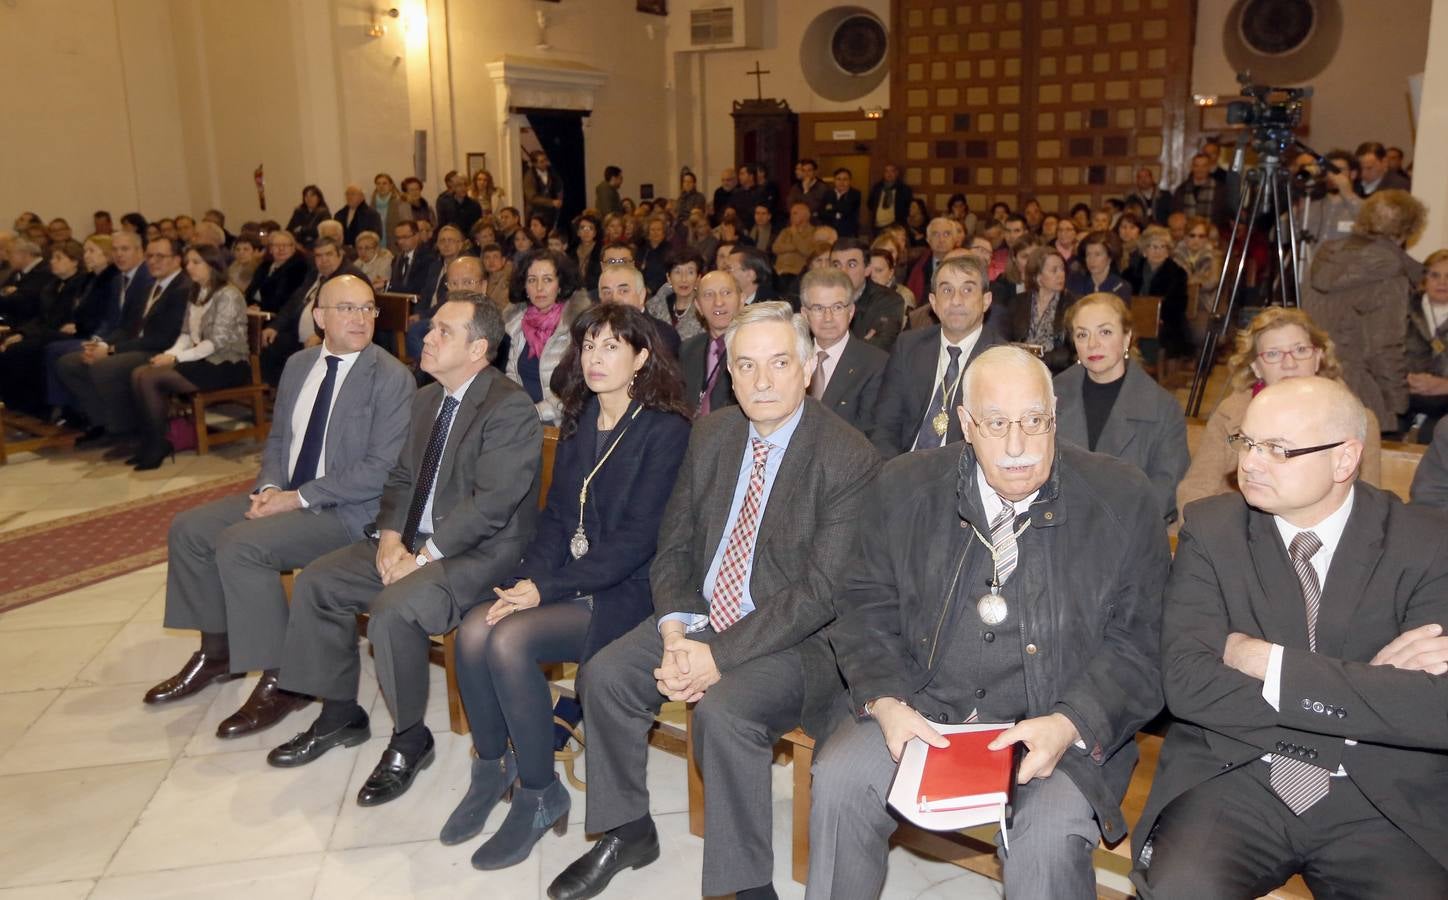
[1192,0,1424,153]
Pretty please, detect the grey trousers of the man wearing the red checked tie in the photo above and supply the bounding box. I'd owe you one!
[579,616,804,896]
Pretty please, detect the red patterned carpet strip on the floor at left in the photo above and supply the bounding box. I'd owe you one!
[0,476,255,612]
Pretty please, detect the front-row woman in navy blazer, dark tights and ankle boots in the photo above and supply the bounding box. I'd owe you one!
[440,304,689,870]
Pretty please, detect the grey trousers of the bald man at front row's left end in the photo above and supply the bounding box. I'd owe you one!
[165,496,350,671]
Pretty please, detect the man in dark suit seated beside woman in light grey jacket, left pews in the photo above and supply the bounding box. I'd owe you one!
[55,237,195,441]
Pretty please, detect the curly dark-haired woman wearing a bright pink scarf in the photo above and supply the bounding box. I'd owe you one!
[505,249,589,425]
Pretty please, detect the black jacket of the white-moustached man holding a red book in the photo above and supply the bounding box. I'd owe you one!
[830,443,1170,841]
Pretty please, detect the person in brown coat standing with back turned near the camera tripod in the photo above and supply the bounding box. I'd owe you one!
[1302,190,1428,431]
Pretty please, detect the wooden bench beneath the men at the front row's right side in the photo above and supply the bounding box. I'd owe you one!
[685,729,1312,900]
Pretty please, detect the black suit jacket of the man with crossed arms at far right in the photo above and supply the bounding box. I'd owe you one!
[1131,482,1448,867]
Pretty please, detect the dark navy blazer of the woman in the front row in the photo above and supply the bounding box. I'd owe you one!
[517,398,689,663]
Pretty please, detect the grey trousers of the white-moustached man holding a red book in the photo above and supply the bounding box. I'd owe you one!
[805,716,1100,900]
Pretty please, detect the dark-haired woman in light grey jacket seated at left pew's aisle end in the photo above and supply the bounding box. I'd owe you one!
[127,245,252,472]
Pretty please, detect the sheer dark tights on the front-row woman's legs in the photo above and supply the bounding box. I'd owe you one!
[458,600,592,790]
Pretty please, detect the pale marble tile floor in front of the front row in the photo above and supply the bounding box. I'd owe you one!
[0,446,1001,900]
